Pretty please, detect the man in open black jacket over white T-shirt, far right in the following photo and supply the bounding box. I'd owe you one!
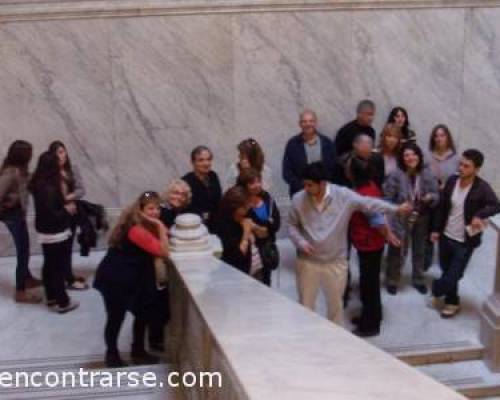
[431,149,500,318]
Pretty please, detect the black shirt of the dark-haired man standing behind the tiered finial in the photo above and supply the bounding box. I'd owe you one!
[182,171,222,233]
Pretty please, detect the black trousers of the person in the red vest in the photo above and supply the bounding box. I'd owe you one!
[358,249,384,331]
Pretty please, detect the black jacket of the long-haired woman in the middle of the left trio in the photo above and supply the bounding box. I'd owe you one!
[33,185,71,234]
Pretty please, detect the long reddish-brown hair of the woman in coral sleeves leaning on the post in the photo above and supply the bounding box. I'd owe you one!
[109,192,161,247]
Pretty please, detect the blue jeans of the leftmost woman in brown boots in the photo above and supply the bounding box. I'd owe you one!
[3,216,31,290]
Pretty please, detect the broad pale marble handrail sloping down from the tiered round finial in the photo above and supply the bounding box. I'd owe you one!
[168,257,464,400]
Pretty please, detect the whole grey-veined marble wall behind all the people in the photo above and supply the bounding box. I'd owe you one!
[0,8,500,208]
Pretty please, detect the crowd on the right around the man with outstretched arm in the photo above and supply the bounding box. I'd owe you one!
[283,100,500,337]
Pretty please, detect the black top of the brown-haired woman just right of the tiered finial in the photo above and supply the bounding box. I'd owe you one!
[217,218,252,274]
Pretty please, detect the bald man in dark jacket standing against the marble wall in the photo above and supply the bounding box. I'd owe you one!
[283,110,335,197]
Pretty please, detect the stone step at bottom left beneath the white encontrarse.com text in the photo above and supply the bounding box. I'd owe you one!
[0,354,178,400]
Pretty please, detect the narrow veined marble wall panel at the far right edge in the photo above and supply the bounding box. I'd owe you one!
[460,9,500,192]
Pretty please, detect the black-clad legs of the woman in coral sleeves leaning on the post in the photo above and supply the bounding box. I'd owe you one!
[102,294,146,354]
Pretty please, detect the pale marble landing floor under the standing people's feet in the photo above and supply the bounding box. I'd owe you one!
[0,230,496,399]
